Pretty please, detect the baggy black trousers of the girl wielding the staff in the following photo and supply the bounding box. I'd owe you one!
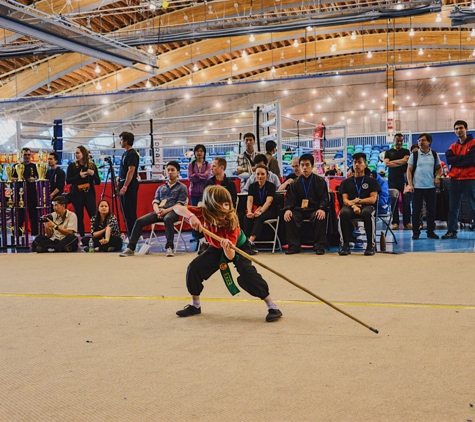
[186,242,269,299]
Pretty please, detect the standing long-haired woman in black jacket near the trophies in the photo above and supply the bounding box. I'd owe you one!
[66,145,101,236]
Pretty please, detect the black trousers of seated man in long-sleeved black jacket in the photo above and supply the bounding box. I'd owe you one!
[285,210,327,251]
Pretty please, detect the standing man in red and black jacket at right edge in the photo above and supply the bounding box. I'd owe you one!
[442,120,475,239]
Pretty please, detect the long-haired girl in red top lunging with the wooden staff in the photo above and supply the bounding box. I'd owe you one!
[173,186,282,322]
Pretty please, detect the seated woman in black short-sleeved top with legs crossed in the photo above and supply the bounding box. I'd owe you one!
[243,165,277,255]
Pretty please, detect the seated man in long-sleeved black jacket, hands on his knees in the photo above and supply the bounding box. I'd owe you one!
[284,154,328,255]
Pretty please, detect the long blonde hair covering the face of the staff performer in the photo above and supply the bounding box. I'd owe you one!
[203,185,239,230]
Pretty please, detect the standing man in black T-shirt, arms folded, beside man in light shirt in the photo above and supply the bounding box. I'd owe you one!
[384,133,412,230]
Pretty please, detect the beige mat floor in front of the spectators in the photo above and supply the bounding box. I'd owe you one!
[0,253,475,422]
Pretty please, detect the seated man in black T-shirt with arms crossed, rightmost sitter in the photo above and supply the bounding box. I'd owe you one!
[339,152,380,256]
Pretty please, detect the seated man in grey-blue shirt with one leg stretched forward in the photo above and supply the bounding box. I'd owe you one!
[120,161,188,257]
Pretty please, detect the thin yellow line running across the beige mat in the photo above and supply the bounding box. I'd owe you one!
[0,293,475,310]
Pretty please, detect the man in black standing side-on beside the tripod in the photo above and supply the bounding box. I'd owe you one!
[119,132,140,237]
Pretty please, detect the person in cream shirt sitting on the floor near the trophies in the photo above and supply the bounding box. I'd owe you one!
[31,196,79,253]
